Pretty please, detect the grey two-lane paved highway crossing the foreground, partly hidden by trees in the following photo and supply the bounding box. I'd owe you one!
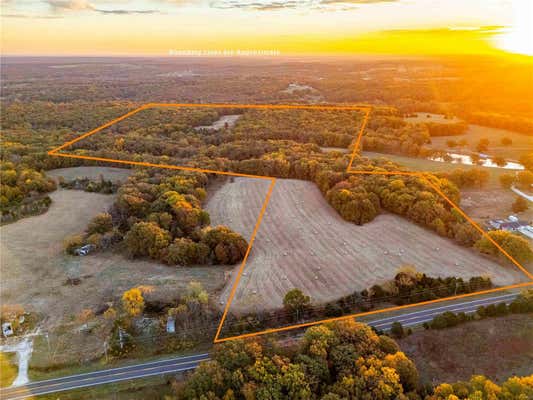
[0,293,518,400]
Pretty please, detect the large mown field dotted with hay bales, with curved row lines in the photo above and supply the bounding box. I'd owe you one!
[207,178,526,312]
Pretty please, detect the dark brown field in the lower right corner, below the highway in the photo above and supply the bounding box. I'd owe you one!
[399,314,533,383]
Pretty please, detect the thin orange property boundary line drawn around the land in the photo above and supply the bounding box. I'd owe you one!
[48,103,533,343]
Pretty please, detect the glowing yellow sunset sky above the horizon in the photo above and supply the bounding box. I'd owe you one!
[1,0,533,55]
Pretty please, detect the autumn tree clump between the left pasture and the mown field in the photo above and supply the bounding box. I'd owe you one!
[110,169,248,265]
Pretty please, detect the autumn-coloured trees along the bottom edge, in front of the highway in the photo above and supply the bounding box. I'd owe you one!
[175,320,533,400]
